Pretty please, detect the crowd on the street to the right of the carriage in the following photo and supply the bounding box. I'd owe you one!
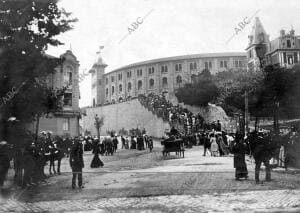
[165,125,300,183]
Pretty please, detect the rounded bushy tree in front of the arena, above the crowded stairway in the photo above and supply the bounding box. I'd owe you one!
[175,70,219,106]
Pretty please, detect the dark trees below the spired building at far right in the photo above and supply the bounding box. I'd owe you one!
[216,65,300,131]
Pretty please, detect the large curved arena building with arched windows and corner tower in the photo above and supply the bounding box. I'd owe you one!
[89,52,247,106]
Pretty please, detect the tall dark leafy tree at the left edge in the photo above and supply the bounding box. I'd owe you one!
[0,0,76,145]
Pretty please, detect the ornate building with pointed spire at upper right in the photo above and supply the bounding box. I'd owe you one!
[246,17,300,70]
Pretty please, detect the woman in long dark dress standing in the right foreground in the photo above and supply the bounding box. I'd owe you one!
[232,135,248,180]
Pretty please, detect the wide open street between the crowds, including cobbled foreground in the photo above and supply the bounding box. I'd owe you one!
[0,142,300,212]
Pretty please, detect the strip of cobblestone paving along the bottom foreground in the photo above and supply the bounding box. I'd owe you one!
[0,190,300,212]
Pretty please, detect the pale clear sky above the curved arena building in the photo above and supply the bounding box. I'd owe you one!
[47,0,300,107]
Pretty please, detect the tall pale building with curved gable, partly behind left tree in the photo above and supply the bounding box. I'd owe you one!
[30,50,80,137]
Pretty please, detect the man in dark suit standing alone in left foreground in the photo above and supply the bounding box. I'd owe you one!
[70,139,84,189]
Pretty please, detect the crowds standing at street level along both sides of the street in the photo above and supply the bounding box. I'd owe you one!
[0,122,300,191]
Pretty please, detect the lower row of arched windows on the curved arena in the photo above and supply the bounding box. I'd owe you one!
[105,75,182,96]
